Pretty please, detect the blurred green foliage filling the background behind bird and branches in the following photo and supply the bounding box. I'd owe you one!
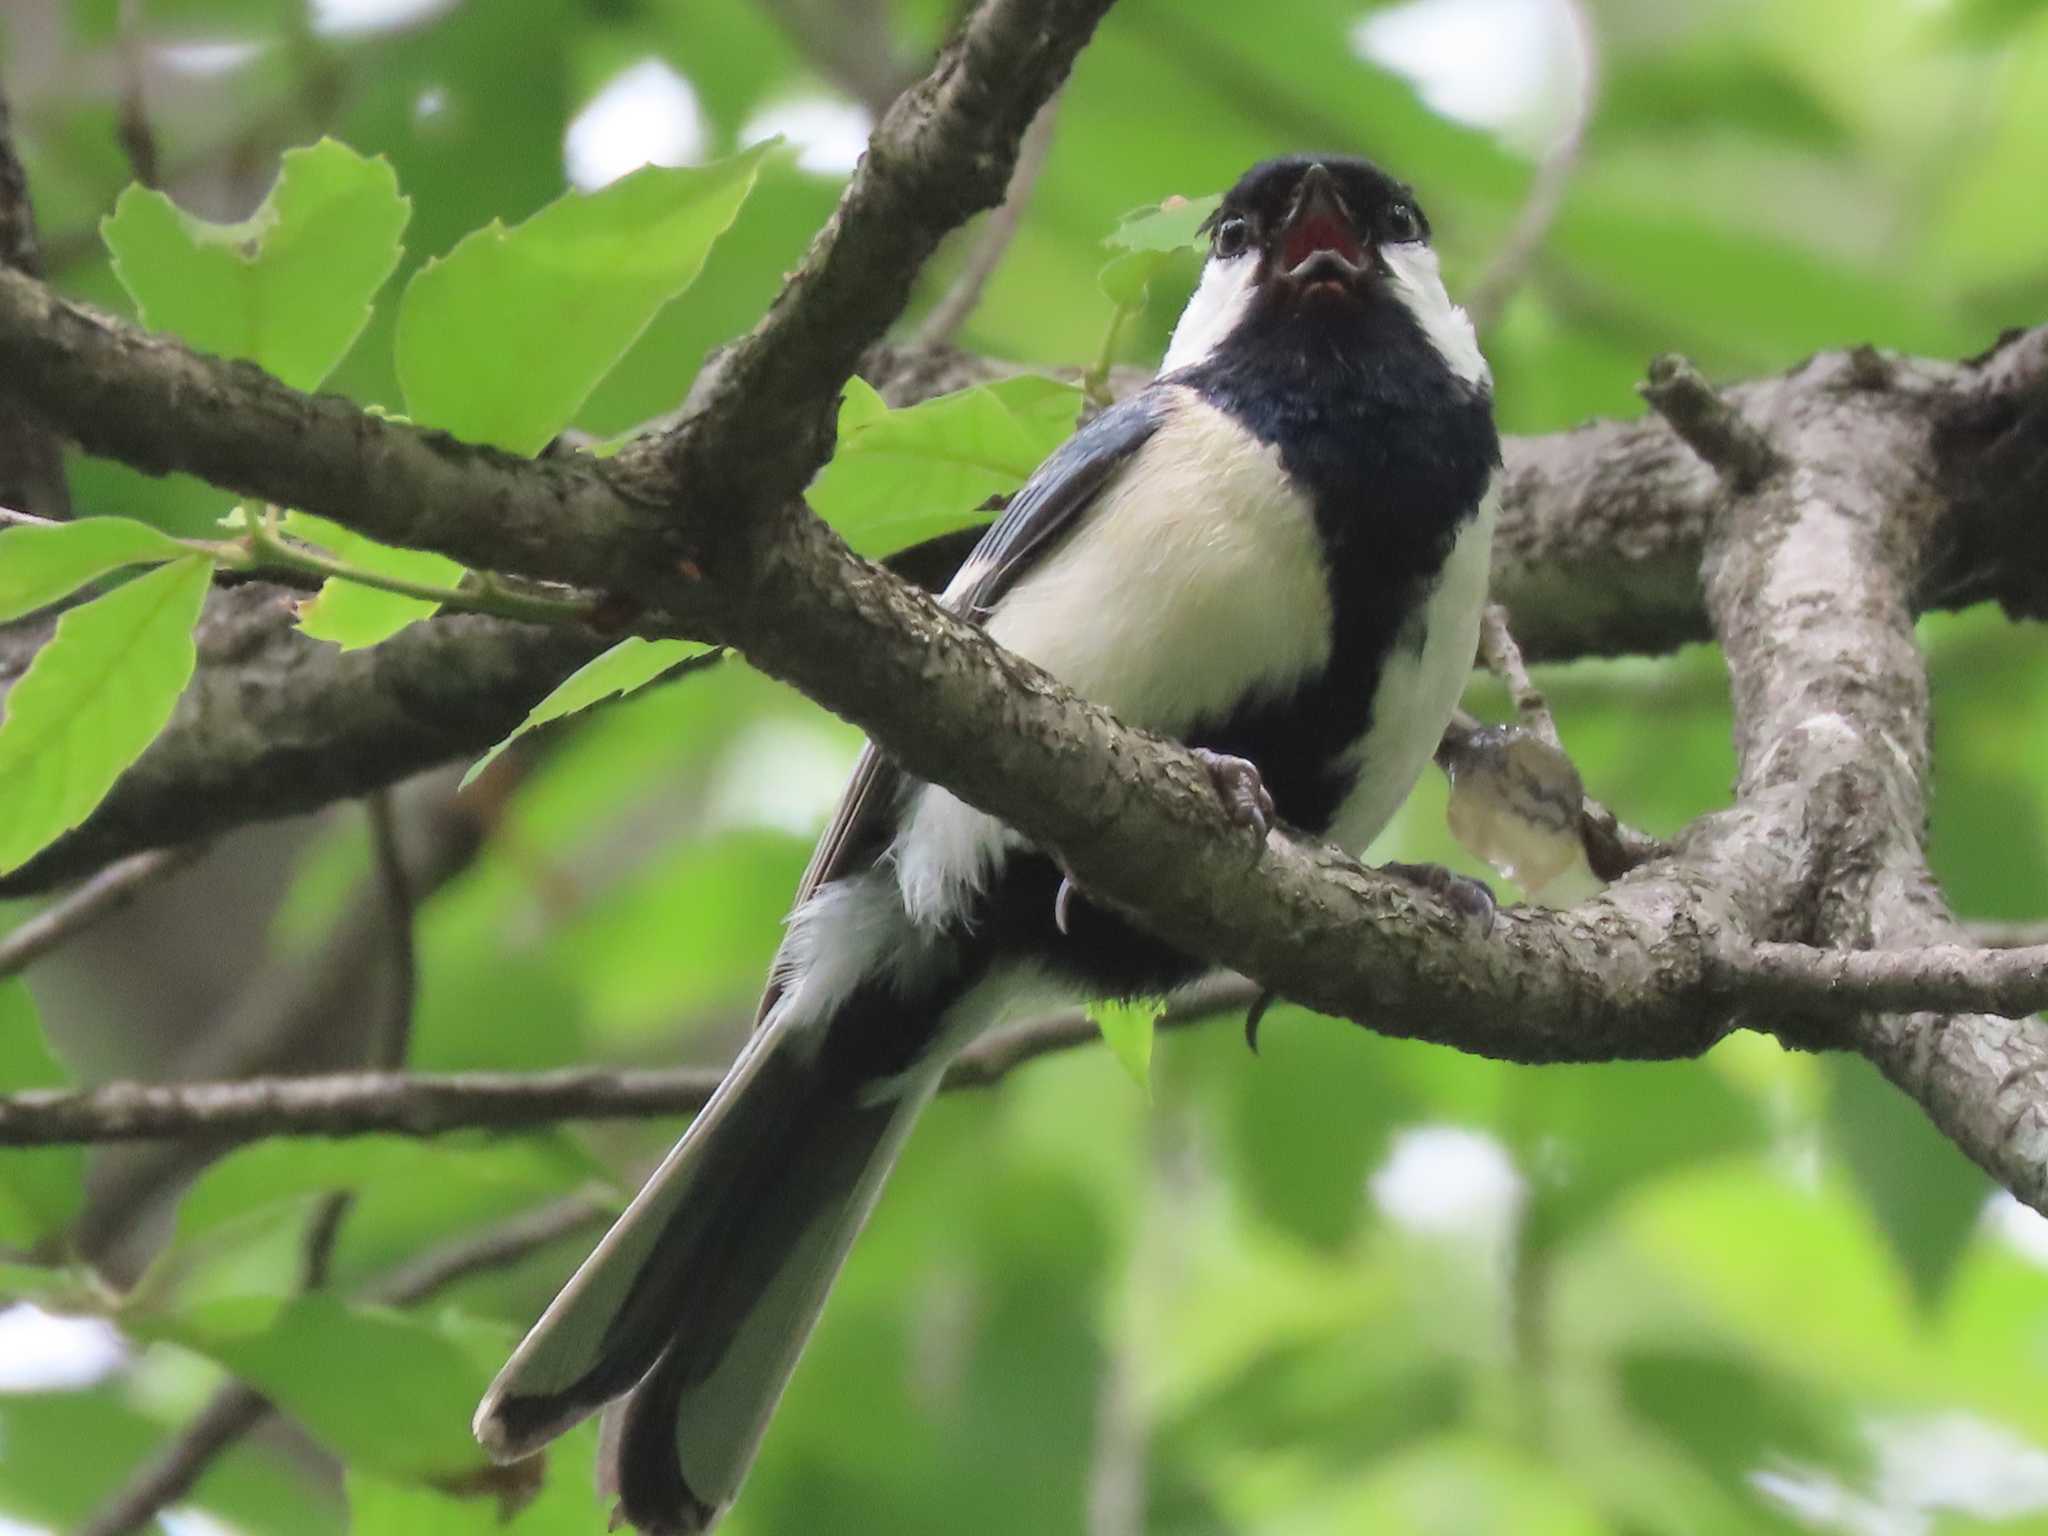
[0,0,2048,1536]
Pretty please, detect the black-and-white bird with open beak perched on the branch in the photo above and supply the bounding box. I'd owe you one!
[475,154,1499,1536]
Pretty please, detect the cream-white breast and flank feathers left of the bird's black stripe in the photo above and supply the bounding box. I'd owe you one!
[891,391,1327,926]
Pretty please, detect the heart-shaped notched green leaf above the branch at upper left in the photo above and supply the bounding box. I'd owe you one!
[100,139,412,389]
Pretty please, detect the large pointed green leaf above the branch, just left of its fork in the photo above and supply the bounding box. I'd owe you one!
[397,141,774,455]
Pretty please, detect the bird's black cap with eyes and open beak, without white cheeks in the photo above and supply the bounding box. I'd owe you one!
[1206,156,1430,301]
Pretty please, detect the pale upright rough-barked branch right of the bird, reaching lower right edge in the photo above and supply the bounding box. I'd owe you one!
[1679,354,2048,1208]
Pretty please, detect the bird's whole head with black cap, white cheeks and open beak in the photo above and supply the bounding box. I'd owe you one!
[1161,156,1487,389]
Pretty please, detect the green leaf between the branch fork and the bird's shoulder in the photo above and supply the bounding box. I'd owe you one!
[805,375,1081,555]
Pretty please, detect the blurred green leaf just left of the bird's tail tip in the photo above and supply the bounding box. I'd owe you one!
[144,1294,510,1477]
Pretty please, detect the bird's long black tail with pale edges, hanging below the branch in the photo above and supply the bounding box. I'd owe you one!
[475,999,936,1536]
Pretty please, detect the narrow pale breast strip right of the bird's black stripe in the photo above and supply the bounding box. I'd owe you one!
[1329,485,1499,854]
